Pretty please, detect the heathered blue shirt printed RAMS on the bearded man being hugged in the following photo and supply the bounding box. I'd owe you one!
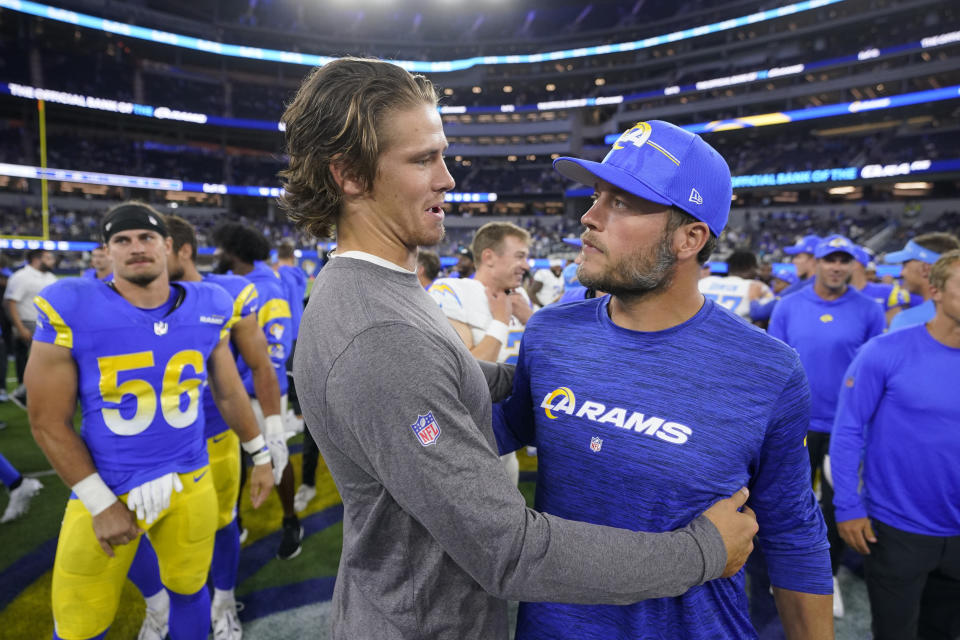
[494,296,828,640]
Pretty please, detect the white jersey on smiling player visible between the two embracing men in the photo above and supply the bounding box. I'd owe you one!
[430,278,530,364]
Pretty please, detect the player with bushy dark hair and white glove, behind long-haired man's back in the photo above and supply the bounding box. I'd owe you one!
[213,222,303,560]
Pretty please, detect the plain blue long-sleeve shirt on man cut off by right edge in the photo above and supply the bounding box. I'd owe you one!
[830,325,960,536]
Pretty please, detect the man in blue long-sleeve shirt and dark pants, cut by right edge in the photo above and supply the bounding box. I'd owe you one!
[830,251,960,640]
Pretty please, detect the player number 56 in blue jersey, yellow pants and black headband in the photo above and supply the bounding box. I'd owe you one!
[26,202,272,640]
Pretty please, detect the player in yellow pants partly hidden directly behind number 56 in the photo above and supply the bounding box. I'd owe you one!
[130,216,280,640]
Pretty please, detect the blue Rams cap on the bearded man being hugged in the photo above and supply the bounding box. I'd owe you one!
[553,120,733,236]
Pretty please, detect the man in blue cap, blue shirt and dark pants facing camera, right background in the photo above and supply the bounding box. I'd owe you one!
[767,235,886,617]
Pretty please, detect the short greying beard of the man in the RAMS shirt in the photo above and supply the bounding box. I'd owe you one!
[577,226,677,300]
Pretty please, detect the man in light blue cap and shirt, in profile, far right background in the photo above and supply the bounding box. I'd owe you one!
[886,233,960,331]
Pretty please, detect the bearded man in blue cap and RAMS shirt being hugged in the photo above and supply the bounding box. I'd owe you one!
[494,121,833,640]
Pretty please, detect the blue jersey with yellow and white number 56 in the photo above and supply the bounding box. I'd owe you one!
[34,278,239,495]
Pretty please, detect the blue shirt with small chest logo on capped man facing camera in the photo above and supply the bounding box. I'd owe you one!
[767,286,886,433]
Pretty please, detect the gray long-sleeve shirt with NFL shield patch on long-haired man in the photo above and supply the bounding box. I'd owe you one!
[294,257,726,640]
